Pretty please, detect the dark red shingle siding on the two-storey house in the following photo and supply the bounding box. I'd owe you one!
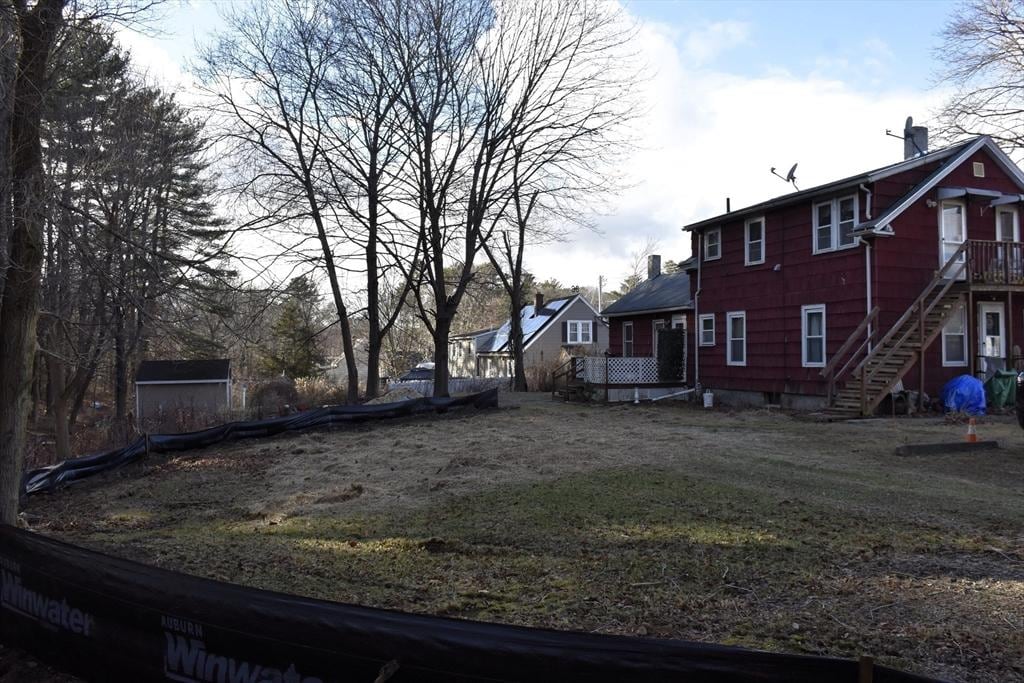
[691,145,1024,395]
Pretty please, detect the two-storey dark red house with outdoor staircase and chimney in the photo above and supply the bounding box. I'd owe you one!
[684,126,1024,415]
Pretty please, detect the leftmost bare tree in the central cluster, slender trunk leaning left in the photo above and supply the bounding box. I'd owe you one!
[198,2,359,402]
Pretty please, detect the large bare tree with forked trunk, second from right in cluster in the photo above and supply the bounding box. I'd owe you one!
[381,0,628,395]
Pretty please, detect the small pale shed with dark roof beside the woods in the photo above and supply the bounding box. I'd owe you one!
[135,358,231,420]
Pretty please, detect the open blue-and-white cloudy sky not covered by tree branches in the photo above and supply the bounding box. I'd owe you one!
[122,0,956,287]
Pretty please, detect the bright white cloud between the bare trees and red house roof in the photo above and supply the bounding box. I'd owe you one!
[526,8,943,285]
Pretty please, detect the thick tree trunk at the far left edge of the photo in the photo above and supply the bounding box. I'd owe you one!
[0,0,65,524]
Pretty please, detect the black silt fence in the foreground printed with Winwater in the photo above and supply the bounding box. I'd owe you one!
[0,526,934,683]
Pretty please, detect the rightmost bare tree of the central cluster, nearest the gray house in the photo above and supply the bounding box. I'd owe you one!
[475,0,638,391]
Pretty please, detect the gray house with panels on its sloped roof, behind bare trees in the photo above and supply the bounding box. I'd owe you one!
[449,294,608,377]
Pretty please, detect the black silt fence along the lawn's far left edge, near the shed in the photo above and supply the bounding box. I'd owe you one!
[23,389,498,496]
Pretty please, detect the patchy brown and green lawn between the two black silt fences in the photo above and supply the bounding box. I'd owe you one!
[29,396,1024,681]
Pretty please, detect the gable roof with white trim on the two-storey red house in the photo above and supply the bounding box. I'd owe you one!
[683,135,1024,230]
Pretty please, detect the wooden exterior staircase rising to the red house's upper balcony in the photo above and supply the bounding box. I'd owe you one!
[821,243,968,417]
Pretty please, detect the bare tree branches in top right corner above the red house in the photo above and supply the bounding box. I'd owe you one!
[936,0,1024,150]
